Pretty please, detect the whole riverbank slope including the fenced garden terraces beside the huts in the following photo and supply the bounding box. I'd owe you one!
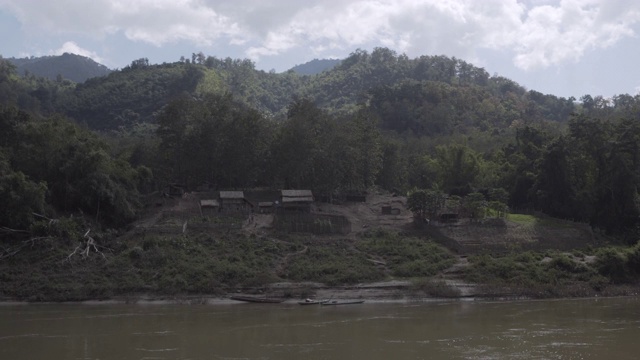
[0,191,640,303]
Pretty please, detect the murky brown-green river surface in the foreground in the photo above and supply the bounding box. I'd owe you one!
[0,298,640,360]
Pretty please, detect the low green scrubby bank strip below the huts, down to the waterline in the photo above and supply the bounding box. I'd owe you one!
[0,232,640,304]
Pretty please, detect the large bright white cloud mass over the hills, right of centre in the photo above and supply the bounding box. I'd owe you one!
[236,0,640,70]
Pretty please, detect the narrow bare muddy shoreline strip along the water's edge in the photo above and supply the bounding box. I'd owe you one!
[0,279,640,305]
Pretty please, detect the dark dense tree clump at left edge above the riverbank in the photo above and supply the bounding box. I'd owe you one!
[0,107,151,230]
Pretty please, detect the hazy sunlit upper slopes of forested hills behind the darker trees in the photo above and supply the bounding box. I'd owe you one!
[42,48,584,131]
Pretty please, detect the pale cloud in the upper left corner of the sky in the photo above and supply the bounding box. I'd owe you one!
[0,0,243,46]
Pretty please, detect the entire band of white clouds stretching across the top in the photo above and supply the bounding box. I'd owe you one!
[0,0,640,70]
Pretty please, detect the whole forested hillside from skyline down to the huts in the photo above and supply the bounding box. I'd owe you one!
[0,48,640,241]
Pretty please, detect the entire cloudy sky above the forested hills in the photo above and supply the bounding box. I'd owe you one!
[0,0,640,100]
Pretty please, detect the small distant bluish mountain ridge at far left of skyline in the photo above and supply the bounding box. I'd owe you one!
[7,53,112,83]
